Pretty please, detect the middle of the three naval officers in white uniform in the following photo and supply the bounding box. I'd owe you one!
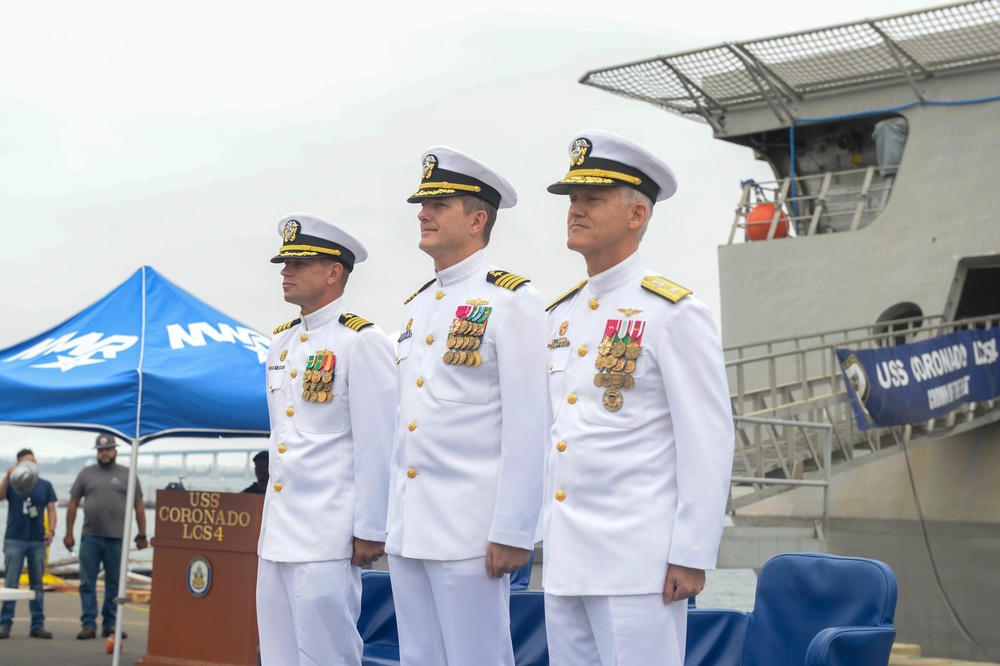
[386,146,546,666]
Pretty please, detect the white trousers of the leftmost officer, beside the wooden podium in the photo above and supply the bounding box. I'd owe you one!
[257,558,363,666]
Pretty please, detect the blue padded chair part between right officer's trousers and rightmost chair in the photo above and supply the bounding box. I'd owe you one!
[684,608,750,666]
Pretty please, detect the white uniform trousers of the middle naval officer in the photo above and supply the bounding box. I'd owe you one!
[389,555,514,666]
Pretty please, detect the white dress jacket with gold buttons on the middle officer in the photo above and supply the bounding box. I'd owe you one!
[386,252,546,560]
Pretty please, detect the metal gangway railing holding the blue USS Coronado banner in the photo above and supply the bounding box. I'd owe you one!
[725,315,1000,510]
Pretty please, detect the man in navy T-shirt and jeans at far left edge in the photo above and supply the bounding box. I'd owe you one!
[0,449,56,638]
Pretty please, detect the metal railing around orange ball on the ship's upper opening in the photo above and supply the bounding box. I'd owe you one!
[728,165,896,245]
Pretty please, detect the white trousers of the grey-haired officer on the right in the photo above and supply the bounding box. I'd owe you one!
[545,594,687,666]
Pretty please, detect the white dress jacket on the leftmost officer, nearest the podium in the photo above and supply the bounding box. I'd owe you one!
[257,298,396,562]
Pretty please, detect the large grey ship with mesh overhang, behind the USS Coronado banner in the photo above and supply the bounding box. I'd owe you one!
[581,0,1000,659]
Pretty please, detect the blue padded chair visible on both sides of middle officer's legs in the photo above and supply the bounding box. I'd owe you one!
[358,570,549,666]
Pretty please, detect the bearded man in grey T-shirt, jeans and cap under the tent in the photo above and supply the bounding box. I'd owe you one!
[63,433,149,640]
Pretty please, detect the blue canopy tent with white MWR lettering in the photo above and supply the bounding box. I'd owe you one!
[0,266,270,665]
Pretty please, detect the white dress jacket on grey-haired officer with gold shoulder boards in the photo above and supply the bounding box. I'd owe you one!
[543,253,734,596]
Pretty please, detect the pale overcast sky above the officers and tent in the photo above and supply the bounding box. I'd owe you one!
[0,0,933,459]
